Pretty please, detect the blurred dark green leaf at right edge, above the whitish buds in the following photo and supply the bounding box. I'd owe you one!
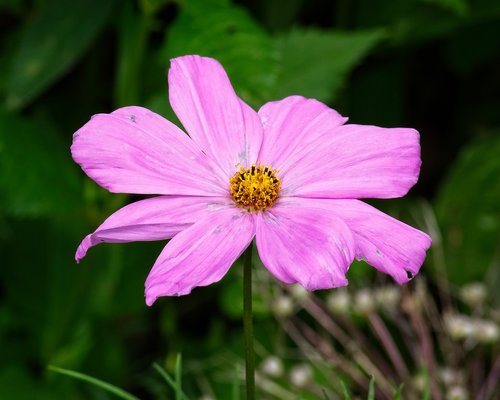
[435,135,500,284]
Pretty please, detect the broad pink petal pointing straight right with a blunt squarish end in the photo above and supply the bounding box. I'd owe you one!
[280,125,421,199]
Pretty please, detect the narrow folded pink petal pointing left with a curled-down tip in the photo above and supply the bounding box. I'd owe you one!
[75,196,232,262]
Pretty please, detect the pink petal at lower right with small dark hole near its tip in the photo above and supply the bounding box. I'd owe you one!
[284,199,432,284]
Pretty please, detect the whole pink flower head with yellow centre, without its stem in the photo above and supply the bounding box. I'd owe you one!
[71,56,431,305]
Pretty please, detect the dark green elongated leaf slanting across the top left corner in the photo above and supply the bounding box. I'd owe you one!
[6,0,114,109]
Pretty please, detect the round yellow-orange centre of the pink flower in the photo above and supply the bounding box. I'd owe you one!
[229,164,281,212]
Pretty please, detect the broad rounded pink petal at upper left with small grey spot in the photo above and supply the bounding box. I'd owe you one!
[71,107,227,196]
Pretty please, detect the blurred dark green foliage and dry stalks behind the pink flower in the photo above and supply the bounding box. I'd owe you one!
[0,0,500,400]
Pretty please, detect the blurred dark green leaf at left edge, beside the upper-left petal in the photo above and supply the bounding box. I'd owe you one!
[0,113,81,216]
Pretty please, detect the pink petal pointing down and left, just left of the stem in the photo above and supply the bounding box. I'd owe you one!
[146,208,255,306]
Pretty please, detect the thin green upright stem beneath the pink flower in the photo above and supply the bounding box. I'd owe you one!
[243,243,255,400]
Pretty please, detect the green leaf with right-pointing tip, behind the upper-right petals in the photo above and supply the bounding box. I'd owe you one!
[274,29,383,101]
